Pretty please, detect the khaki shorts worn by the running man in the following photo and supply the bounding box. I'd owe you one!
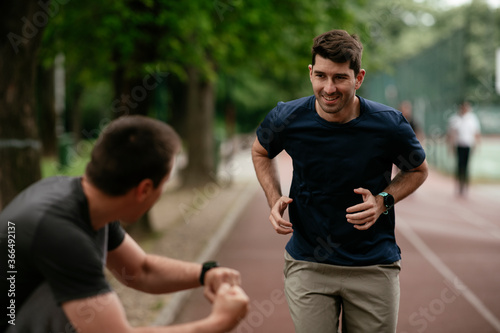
[284,251,401,333]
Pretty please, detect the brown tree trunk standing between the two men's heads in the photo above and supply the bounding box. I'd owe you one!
[183,68,216,187]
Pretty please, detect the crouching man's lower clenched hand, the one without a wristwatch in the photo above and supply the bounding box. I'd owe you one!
[209,283,250,332]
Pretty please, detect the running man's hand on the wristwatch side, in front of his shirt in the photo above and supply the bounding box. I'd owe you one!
[346,187,384,230]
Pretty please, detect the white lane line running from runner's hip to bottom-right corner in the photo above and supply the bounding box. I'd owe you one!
[397,218,500,332]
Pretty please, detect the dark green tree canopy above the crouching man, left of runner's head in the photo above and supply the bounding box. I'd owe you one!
[41,0,366,135]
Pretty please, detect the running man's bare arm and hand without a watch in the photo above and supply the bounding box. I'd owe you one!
[252,139,293,235]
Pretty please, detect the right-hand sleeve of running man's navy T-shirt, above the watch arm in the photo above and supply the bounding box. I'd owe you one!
[392,115,425,171]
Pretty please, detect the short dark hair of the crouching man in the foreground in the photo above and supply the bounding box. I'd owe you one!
[85,115,181,196]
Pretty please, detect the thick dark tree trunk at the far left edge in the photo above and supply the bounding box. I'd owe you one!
[0,0,44,209]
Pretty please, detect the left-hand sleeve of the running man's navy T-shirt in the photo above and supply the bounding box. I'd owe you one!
[257,103,286,158]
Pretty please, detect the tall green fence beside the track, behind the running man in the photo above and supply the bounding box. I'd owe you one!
[360,28,500,179]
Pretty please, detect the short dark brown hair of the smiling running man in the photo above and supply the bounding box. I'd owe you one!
[312,30,363,75]
